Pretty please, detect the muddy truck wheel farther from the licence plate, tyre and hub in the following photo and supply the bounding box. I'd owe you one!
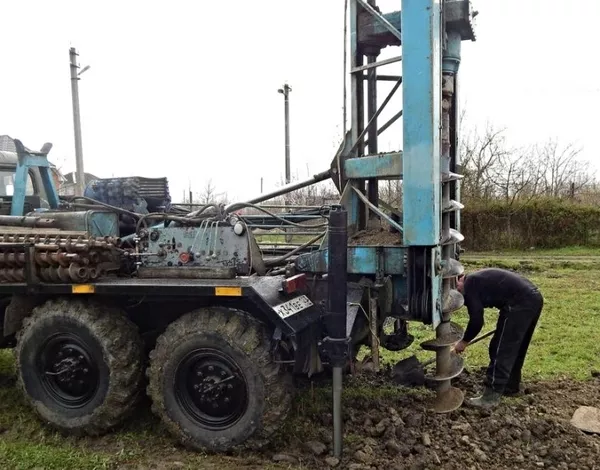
[15,299,143,435]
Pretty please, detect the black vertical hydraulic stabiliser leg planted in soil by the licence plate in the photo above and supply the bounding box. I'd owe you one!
[327,205,348,458]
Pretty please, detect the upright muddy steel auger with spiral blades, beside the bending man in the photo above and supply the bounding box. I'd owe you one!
[421,74,464,413]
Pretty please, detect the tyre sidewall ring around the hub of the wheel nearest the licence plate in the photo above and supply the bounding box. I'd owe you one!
[161,332,265,451]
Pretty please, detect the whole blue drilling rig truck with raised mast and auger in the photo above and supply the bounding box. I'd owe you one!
[0,0,475,455]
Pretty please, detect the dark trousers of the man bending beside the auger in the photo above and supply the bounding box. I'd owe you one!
[485,289,544,394]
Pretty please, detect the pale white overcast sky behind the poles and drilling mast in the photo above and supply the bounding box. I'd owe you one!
[0,0,600,200]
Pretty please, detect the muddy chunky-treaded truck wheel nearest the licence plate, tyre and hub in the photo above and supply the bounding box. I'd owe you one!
[147,307,292,452]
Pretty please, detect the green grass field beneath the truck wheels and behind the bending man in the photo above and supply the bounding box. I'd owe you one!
[0,249,600,470]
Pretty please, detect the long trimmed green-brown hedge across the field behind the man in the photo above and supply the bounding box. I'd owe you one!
[461,199,600,251]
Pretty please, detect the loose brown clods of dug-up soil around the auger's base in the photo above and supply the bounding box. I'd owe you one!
[271,371,600,470]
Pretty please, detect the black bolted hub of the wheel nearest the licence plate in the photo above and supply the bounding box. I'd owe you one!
[176,349,248,429]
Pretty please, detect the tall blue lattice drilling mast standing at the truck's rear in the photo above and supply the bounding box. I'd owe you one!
[299,0,474,326]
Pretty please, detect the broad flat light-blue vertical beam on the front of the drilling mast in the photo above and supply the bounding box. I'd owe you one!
[402,0,442,246]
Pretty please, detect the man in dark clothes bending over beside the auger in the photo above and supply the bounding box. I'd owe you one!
[454,268,544,407]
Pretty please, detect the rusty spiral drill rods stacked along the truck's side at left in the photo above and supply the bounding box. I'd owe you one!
[0,227,120,283]
